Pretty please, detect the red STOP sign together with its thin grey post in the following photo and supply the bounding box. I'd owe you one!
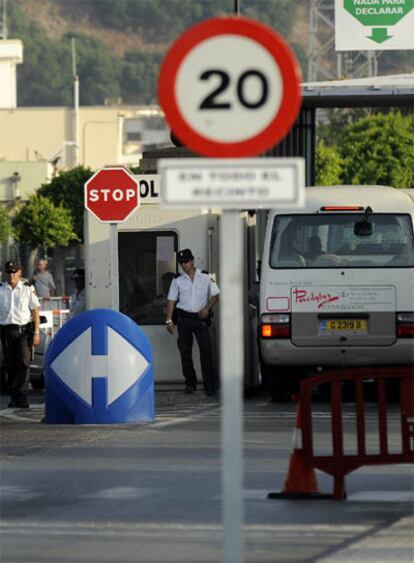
[84,166,140,311]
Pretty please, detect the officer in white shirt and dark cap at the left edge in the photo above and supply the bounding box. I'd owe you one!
[0,261,40,408]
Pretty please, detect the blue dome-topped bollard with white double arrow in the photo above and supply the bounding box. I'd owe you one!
[45,309,155,424]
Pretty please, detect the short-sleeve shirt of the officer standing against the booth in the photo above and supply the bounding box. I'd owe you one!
[168,269,220,313]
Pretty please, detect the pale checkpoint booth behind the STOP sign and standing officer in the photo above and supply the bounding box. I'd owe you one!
[85,174,258,387]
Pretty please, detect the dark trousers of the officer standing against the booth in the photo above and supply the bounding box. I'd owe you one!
[177,315,216,390]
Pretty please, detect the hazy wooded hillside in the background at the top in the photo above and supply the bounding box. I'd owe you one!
[8,0,411,106]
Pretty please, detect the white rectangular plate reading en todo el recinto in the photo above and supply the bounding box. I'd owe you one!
[158,158,305,209]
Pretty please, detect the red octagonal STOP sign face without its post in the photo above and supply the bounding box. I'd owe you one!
[85,167,140,223]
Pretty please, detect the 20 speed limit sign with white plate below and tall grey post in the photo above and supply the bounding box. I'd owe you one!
[158,17,304,563]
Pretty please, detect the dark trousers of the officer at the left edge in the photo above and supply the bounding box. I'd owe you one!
[1,324,31,406]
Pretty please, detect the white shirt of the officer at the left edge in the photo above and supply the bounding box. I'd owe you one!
[0,281,40,326]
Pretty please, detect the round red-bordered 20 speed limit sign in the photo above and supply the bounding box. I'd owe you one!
[159,17,301,157]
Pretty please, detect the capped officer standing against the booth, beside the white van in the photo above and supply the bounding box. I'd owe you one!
[166,248,220,396]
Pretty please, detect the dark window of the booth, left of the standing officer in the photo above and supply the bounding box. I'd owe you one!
[118,231,178,325]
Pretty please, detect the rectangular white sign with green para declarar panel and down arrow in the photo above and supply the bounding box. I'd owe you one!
[335,0,414,51]
